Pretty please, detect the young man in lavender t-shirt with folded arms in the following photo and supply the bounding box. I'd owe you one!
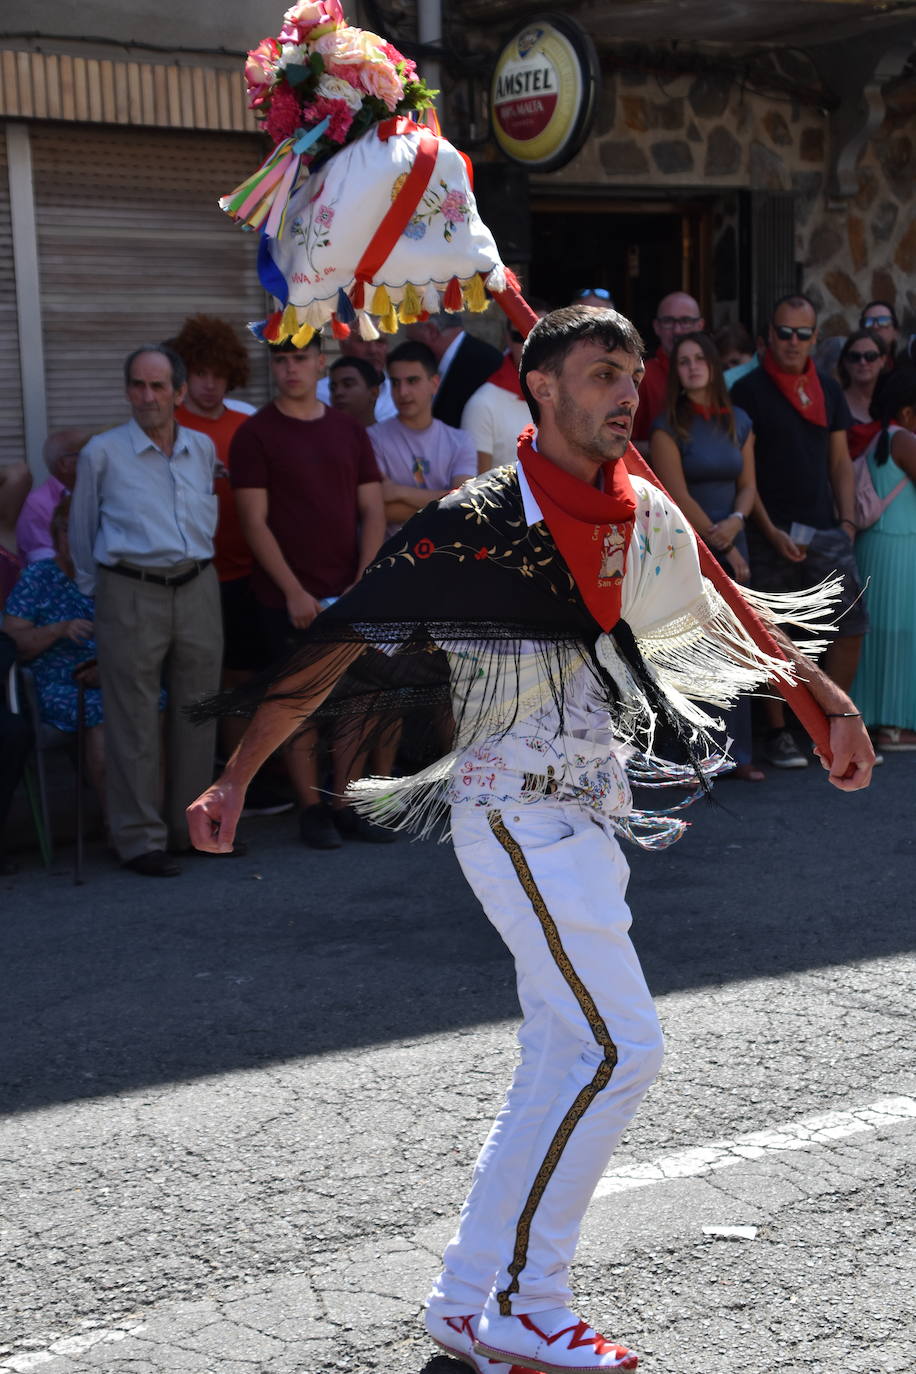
[368,344,477,534]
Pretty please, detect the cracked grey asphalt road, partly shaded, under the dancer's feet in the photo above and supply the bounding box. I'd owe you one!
[0,754,916,1374]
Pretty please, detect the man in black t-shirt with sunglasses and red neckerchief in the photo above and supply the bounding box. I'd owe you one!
[732,295,868,768]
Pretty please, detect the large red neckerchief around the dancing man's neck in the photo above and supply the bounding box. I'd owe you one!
[518,425,636,631]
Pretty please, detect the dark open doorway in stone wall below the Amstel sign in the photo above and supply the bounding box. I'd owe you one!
[527,195,713,350]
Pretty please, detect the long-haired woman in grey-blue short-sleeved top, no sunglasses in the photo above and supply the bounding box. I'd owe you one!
[650,334,766,782]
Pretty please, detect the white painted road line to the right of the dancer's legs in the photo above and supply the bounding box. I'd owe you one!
[595,1098,916,1198]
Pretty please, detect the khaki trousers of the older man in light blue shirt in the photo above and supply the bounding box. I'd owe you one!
[95,566,222,863]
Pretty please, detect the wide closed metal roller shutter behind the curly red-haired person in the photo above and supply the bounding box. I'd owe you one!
[32,124,274,430]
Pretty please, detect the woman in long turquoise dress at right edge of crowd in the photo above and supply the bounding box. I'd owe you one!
[853,367,916,750]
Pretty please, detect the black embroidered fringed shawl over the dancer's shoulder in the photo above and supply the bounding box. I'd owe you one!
[192,467,736,829]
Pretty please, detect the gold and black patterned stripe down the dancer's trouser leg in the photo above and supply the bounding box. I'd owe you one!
[488,811,617,1316]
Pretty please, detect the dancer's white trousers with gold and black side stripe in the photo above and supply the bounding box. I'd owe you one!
[427,802,662,1316]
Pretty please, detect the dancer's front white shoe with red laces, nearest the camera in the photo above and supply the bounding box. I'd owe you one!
[474,1307,639,1374]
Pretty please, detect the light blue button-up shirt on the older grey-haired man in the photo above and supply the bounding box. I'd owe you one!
[69,419,217,596]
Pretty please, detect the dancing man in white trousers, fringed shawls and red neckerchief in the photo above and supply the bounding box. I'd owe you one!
[190,306,873,1374]
